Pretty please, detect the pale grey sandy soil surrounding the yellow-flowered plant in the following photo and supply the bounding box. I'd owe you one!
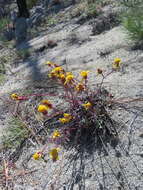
[0,1,143,190]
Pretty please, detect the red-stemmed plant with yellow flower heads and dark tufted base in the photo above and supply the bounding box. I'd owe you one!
[11,58,121,161]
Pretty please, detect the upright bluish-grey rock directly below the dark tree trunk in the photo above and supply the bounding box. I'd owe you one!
[15,17,27,44]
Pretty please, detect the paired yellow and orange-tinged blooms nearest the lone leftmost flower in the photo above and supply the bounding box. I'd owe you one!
[38,100,52,114]
